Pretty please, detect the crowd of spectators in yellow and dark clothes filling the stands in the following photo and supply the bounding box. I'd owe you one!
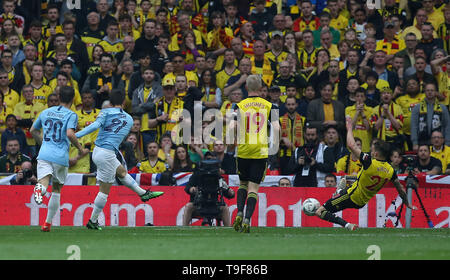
[0,0,450,186]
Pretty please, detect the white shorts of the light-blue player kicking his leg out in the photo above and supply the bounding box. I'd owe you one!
[92,146,122,184]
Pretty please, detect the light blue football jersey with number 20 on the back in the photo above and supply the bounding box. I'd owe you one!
[33,106,78,166]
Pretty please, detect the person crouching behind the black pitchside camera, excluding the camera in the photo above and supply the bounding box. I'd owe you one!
[183,151,235,227]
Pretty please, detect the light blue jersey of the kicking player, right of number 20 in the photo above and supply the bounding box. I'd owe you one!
[76,108,133,151]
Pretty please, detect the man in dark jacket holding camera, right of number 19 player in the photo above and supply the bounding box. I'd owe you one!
[289,125,334,187]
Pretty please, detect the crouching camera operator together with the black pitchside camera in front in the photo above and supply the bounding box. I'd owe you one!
[183,151,234,227]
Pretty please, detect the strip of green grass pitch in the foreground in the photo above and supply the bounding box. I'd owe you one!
[0,226,450,260]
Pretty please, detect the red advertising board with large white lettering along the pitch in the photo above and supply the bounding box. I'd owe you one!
[0,184,450,228]
